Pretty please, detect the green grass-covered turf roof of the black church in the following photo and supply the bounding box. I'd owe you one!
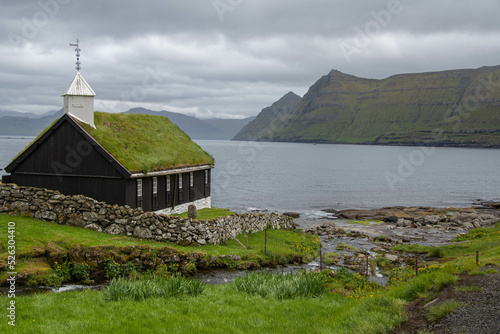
[80,112,214,173]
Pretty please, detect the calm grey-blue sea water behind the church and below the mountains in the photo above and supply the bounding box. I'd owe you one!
[0,136,500,218]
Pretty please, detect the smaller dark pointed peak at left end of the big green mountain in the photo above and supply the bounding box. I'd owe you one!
[233,92,302,140]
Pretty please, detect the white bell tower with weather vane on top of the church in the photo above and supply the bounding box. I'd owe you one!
[62,40,96,128]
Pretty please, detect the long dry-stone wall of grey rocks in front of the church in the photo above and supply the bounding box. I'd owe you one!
[0,183,295,245]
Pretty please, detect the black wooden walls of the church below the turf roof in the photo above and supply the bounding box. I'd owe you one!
[10,116,211,211]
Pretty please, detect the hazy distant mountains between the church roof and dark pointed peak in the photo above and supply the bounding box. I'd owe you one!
[127,108,254,140]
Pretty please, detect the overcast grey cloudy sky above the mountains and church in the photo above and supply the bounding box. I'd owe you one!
[0,0,500,118]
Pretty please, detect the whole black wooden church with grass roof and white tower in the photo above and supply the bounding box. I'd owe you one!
[3,53,214,214]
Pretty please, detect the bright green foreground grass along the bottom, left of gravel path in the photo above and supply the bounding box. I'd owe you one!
[0,276,404,334]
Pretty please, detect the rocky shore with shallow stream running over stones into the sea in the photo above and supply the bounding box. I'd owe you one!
[304,202,500,276]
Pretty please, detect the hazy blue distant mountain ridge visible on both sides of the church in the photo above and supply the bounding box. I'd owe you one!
[0,108,254,140]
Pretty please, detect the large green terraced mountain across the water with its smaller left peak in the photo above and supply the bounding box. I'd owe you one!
[235,66,500,147]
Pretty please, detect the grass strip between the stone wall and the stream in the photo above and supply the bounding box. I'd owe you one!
[0,214,320,285]
